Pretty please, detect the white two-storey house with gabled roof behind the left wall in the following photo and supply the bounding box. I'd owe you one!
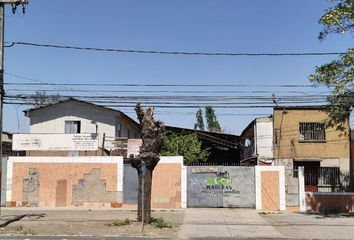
[18,98,141,156]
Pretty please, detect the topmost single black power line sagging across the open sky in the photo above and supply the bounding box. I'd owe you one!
[6,41,345,57]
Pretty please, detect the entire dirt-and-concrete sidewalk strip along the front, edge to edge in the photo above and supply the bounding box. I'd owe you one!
[0,208,354,239]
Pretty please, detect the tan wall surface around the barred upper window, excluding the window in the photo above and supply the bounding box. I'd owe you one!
[273,108,349,170]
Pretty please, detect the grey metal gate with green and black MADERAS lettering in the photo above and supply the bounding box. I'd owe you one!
[187,166,256,208]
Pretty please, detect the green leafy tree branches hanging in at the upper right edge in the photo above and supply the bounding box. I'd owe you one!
[309,0,354,130]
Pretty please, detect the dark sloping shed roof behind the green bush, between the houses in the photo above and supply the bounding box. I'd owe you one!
[166,126,240,149]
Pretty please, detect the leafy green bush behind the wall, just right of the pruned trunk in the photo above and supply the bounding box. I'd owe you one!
[161,133,209,164]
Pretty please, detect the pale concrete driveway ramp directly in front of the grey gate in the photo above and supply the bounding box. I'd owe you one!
[178,208,283,239]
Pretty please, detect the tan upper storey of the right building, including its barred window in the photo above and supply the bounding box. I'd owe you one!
[273,106,350,173]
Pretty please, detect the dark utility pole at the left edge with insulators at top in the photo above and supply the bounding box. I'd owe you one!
[0,0,28,219]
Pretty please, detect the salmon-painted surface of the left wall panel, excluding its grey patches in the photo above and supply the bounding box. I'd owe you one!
[11,163,117,207]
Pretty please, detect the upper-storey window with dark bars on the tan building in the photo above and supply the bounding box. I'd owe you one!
[299,122,326,141]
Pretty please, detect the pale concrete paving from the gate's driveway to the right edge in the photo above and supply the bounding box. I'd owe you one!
[178,208,354,239]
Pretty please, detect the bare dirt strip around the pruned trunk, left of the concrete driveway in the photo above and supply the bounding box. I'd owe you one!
[0,210,184,238]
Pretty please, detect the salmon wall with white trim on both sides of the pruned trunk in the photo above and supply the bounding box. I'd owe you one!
[6,156,187,208]
